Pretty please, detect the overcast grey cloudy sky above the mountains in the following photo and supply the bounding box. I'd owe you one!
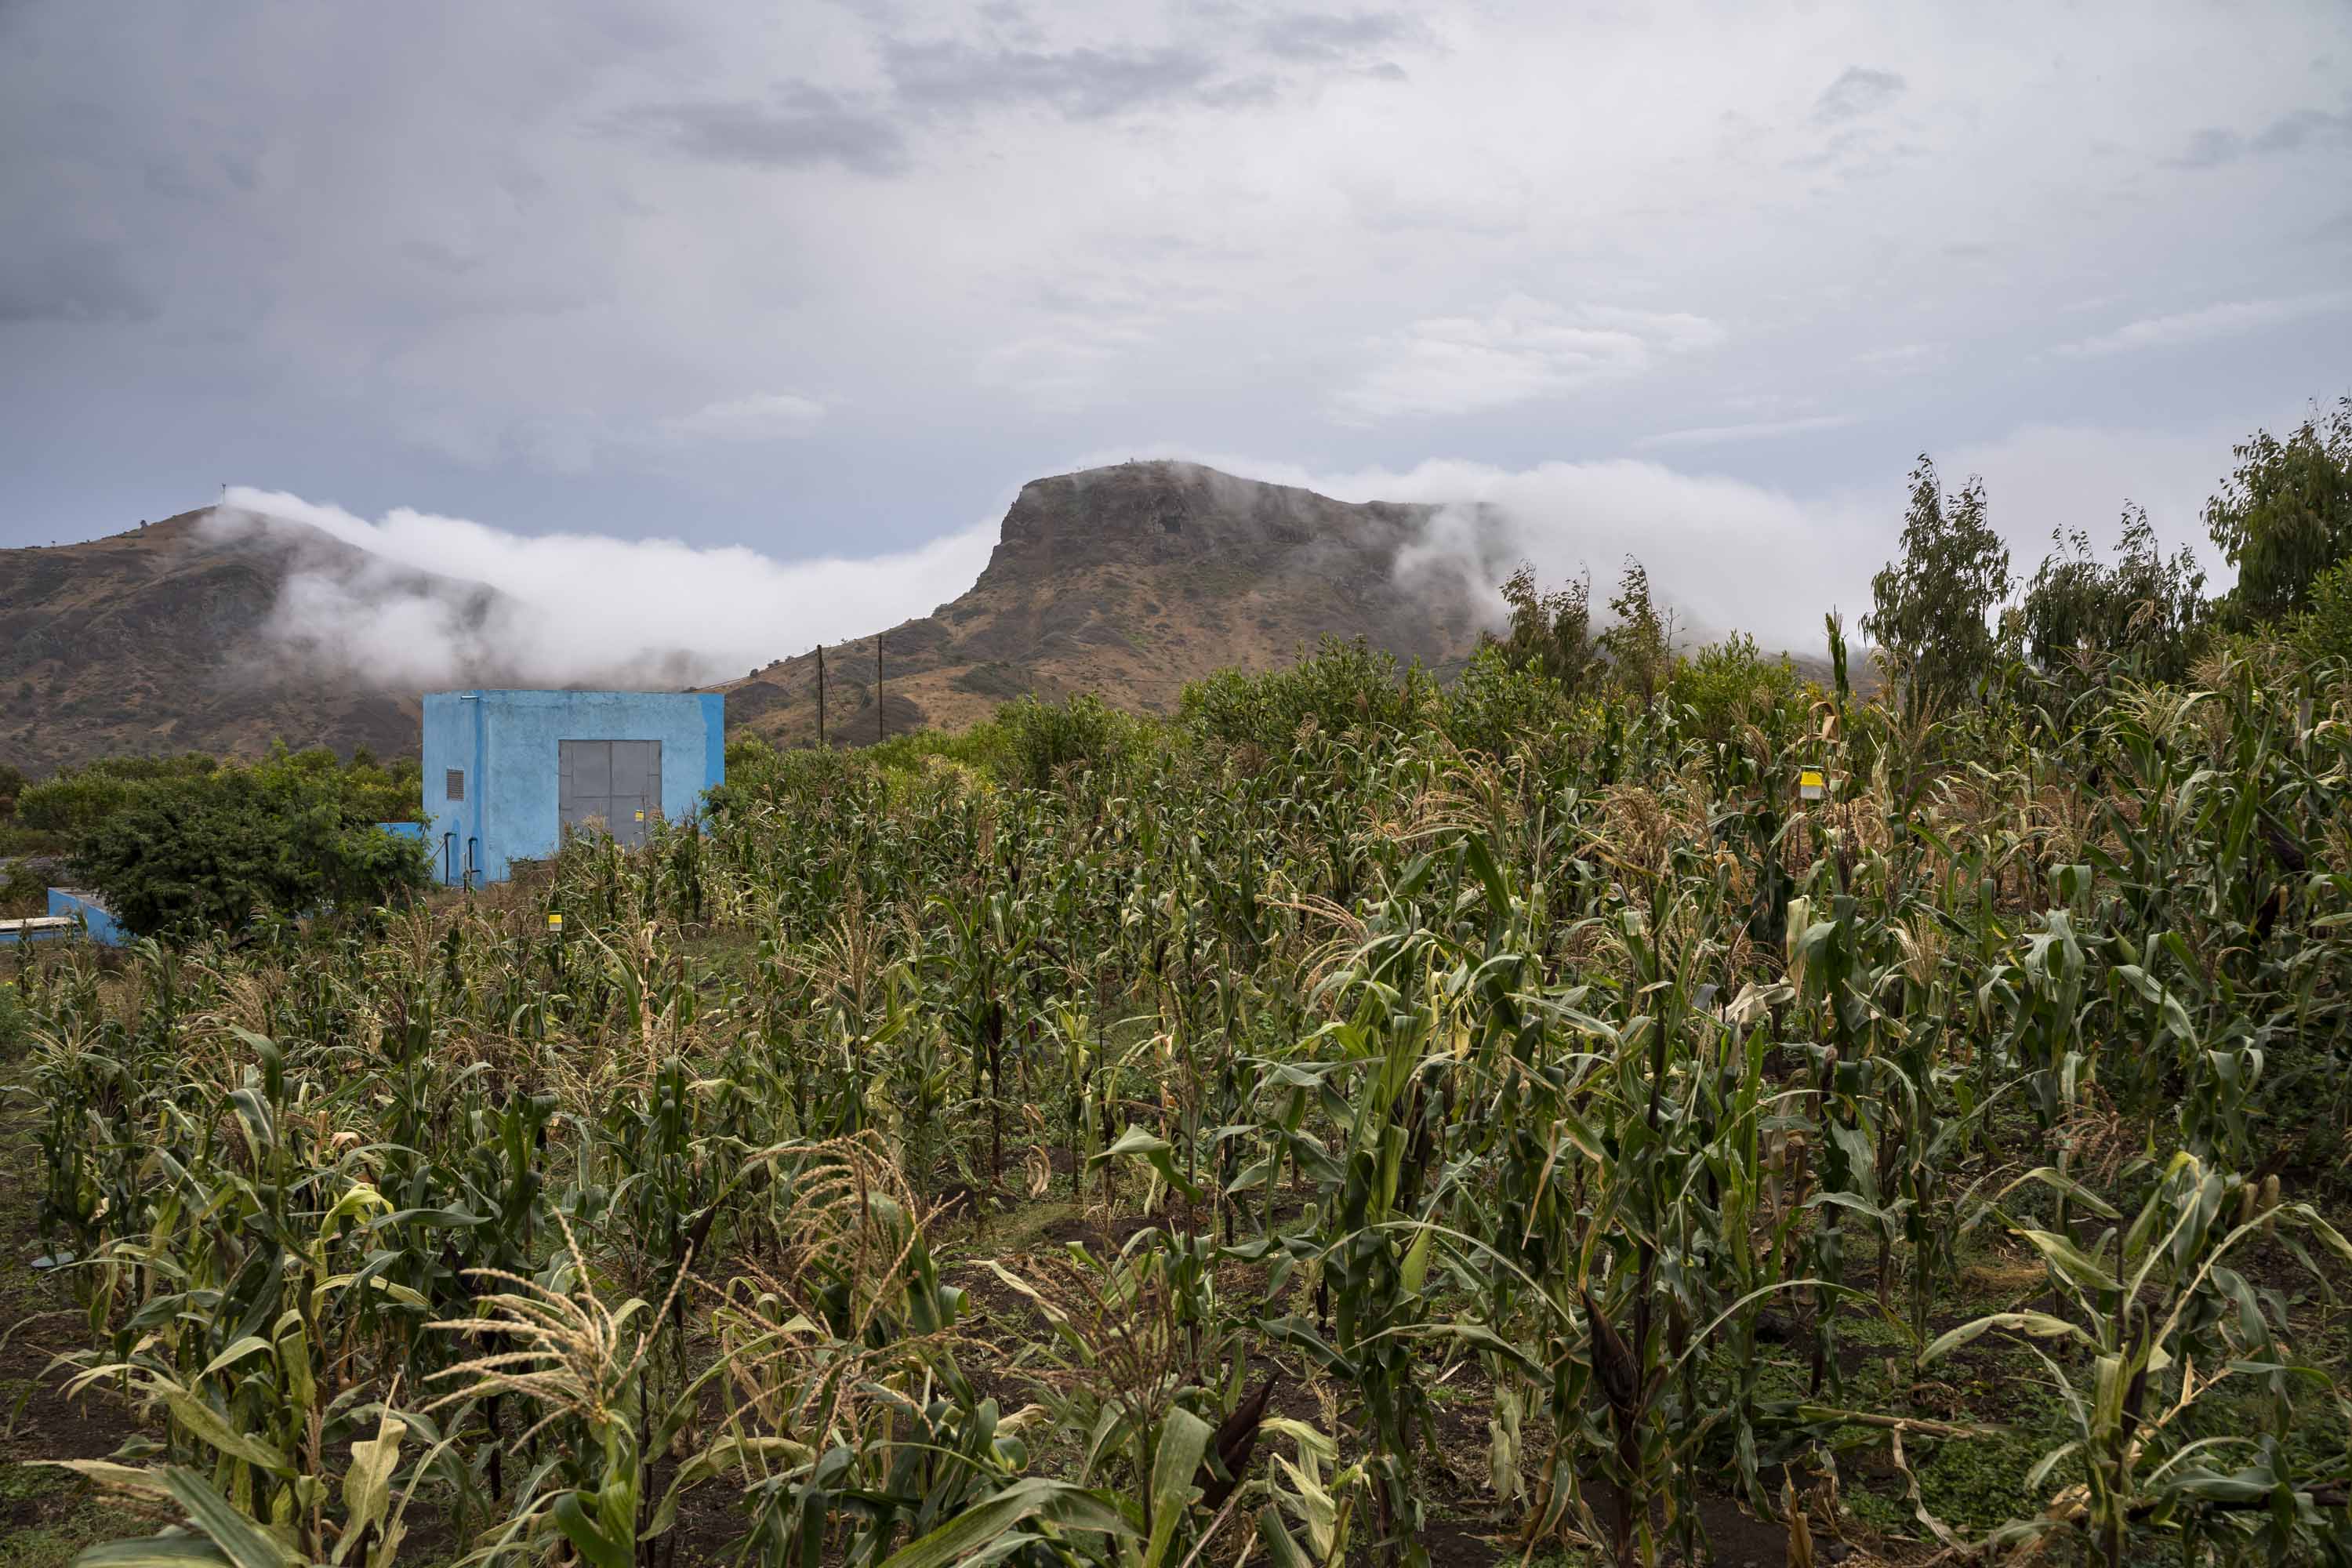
[0,0,2352,652]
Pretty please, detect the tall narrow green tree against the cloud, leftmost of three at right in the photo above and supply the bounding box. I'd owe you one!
[1863,454,2011,706]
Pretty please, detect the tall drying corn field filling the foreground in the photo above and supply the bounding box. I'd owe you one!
[12,639,2352,1568]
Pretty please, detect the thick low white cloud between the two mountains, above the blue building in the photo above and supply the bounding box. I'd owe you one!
[209,487,997,691]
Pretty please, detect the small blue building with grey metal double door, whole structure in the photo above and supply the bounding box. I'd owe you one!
[423,691,727,886]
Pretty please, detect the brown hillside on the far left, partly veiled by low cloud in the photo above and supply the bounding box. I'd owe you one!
[0,510,489,774]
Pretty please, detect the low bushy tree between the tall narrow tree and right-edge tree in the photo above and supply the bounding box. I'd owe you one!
[2020,506,2206,682]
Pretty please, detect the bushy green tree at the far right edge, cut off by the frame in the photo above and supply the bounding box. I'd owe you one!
[2206,395,2352,623]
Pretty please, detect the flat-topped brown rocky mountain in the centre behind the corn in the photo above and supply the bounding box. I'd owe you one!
[720,463,1501,746]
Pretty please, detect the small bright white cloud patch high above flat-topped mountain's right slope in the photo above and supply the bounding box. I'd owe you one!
[1334,294,1724,421]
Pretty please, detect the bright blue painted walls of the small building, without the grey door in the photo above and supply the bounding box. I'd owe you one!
[423,691,727,884]
